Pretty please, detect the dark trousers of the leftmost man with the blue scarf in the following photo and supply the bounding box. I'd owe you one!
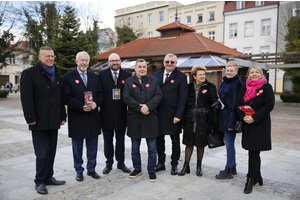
[32,130,58,184]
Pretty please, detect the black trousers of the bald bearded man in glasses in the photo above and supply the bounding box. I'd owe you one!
[102,129,126,165]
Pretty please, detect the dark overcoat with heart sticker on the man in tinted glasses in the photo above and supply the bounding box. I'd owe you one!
[154,68,188,135]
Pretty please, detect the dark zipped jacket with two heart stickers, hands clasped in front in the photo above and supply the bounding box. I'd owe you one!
[123,75,162,138]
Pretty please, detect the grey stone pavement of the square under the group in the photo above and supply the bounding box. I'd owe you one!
[0,94,300,200]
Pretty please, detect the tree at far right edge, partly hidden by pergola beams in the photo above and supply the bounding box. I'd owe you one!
[284,16,300,93]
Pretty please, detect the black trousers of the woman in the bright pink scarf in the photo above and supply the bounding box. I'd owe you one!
[247,151,261,178]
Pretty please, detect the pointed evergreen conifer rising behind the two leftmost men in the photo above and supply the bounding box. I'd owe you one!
[52,6,92,75]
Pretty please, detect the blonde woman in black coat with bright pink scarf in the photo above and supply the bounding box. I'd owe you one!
[236,66,275,194]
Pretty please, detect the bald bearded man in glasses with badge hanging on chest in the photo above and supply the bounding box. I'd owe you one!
[99,53,131,174]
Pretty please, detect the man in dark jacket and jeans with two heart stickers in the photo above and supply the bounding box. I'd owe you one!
[123,59,162,181]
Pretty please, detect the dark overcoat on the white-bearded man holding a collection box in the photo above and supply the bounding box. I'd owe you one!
[63,68,103,139]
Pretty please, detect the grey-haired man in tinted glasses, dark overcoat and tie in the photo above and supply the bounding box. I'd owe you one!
[154,54,188,175]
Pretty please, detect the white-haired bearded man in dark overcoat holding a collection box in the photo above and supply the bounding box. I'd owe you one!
[63,51,103,181]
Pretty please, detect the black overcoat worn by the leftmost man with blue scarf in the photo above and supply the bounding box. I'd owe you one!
[20,61,66,130]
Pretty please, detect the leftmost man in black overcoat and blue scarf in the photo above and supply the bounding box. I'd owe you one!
[21,46,66,194]
